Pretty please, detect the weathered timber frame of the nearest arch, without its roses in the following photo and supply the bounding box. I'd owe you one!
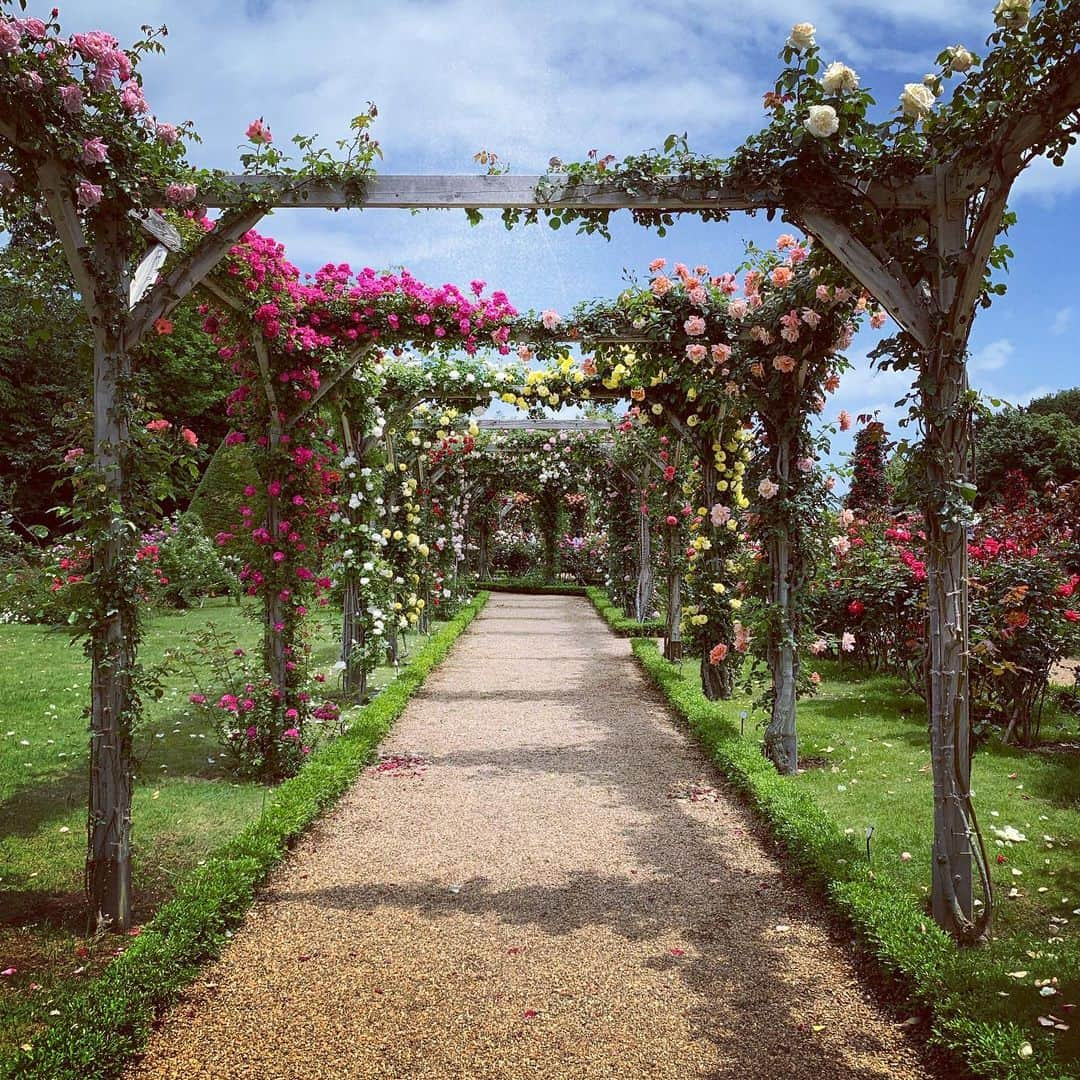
[0,39,1080,936]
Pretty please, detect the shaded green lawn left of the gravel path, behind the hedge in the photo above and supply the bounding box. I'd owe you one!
[0,602,477,1071]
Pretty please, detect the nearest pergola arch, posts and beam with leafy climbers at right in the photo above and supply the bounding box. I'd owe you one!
[0,0,1080,939]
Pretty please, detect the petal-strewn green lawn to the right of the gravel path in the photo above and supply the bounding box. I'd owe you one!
[647,653,1080,1078]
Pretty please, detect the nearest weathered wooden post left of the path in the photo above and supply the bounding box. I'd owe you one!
[84,211,137,932]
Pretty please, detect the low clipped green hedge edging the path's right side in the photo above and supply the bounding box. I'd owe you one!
[631,638,1067,1080]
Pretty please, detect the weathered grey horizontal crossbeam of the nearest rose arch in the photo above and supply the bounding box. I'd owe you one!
[196,174,932,213]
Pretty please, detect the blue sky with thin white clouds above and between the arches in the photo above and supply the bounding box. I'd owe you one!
[29,0,1080,450]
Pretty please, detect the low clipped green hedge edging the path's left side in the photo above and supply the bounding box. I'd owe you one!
[6,592,489,1080]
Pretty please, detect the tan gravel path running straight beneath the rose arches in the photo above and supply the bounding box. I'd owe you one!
[131,595,930,1080]
